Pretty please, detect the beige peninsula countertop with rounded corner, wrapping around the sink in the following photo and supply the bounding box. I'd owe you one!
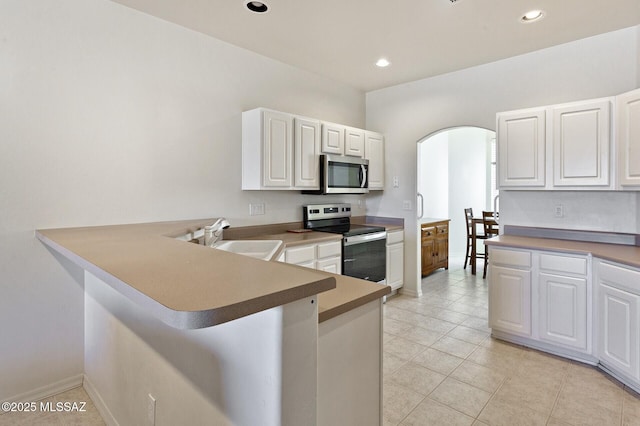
[36,219,390,328]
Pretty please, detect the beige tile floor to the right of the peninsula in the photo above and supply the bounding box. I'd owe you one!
[383,259,640,426]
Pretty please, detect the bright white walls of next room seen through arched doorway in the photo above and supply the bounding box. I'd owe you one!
[416,126,497,284]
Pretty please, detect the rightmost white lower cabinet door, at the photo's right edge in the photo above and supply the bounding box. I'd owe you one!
[598,283,640,380]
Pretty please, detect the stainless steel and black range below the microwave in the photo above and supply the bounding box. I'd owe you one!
[302,204,387,284]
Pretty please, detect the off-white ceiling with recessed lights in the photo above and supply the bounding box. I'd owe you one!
[113,0,640,91]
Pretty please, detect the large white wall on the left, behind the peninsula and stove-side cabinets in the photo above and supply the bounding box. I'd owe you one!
[0,0,365,400]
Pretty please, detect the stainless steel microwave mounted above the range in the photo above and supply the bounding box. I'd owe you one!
[303,155,369,194]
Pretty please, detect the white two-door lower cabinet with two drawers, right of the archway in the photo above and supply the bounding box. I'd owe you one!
[489,248,592,354]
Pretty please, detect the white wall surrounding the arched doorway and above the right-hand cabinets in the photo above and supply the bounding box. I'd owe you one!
[366,27,639,294]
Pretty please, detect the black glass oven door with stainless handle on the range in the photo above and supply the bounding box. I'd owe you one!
[342,232,387,283]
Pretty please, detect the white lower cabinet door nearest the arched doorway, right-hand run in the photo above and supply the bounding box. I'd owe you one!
[489,263,531,336]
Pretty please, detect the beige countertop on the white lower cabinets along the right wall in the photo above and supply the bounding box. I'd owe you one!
[484,235,640,268]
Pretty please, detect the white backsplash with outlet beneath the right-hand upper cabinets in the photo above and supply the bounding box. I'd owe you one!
[500,191,640,234]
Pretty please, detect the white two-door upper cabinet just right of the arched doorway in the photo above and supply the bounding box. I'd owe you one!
[497,98,615,190]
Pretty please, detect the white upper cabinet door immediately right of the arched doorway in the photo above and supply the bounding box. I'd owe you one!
[497,108,546,188]
